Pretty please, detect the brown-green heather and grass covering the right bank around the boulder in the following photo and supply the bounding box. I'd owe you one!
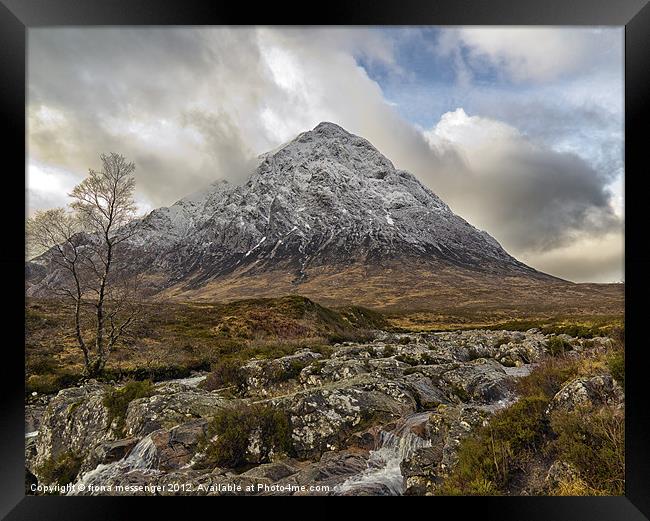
[436,338,625,495]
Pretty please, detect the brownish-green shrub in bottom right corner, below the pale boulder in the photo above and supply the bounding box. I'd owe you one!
[551,406,625,495]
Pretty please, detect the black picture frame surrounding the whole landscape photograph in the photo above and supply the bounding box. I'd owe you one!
[0,0,650,521]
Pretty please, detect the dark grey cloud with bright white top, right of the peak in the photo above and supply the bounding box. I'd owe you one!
[420,109,622,252]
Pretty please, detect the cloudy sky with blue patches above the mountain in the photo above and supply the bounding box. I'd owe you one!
[27,27,624,282]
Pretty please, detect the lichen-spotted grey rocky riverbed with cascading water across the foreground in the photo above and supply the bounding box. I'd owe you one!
[26,329,620,495]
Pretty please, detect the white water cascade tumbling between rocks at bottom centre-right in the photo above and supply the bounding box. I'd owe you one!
[334,413,431,496]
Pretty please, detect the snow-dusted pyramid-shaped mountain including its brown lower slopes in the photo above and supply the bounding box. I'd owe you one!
[29,122,624,307]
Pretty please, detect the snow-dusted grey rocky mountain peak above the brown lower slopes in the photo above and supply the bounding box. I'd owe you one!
[27,122,541,300]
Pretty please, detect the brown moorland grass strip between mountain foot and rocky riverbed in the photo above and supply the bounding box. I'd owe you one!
[25,280,623,393]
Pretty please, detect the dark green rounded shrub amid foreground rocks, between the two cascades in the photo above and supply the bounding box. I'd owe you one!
[195,405,293,468]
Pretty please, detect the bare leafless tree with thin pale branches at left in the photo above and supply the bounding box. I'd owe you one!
[27,153,139,376]
